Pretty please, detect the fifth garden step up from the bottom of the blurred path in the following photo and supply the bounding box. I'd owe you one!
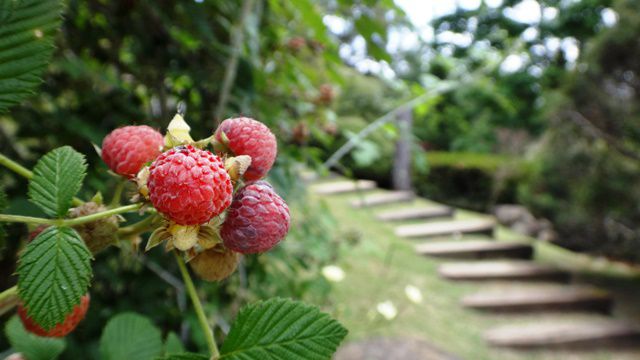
[396,219,496,238]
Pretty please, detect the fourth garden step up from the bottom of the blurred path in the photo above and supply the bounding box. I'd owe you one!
[415,240,533,259]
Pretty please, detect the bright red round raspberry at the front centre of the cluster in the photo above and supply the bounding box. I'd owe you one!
[147,145,233,225]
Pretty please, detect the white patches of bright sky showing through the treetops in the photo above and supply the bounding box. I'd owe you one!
[325,0,617,77]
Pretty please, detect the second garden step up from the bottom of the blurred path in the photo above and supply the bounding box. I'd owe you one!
[462,287,612,313]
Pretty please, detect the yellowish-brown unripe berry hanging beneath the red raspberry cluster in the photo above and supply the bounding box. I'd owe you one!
[189,248,240,281]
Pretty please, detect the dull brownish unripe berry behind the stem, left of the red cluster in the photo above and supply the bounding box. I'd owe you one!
[69,202,118,254]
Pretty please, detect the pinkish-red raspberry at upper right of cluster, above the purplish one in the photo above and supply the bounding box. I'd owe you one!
[215,117,278,181]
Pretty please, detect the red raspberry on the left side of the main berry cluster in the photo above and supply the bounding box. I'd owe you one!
[102,125,164,179]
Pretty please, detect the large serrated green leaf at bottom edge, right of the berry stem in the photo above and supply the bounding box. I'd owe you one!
[221,298,347,360]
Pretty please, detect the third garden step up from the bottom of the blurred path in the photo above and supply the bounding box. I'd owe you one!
[438,261,569,281]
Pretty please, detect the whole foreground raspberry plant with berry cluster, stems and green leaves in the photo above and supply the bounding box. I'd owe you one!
[0,0,347,360]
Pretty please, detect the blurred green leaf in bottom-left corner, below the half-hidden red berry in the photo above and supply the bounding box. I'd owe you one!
[5,316,66,360]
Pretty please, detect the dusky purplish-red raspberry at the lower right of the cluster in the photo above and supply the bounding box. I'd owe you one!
[220,181,289,254]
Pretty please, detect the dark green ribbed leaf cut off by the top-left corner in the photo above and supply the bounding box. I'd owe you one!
[0,0,63,113]
